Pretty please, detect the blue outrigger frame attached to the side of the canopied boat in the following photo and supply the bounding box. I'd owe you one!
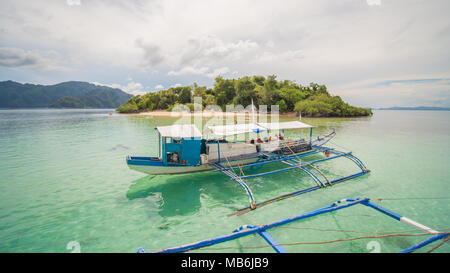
[210,146,370,216]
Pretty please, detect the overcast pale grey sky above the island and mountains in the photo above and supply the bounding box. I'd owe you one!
[0,0,450,107]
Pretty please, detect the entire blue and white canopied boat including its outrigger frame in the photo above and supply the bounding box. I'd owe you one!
[126,121,369,215]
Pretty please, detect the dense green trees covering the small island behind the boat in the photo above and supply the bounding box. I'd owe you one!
[117,75,372,117]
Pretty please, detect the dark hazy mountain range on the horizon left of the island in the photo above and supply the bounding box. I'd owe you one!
[0,81,132,108]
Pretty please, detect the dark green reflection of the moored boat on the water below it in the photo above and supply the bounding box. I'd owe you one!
[126,163,324,218]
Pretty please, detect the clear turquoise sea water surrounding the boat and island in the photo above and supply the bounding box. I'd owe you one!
[0,109,450,252]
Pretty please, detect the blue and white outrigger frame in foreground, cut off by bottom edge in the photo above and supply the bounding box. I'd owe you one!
[138,198,450,253]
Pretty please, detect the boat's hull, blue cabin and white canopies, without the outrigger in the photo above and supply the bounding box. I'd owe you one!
[127,121,335,174]
